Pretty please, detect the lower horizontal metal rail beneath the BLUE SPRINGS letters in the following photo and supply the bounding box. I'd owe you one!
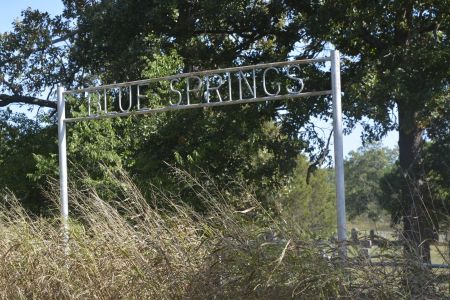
[64,90,332,123]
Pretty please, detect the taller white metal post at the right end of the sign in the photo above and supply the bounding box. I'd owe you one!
[330,50,347,259]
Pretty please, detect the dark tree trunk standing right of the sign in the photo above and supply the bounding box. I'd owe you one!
[398,103,433,263]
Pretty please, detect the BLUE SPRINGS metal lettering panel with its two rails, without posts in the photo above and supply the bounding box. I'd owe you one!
[63,58,331,123]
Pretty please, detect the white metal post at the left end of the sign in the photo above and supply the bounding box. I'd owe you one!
[57,86,69,246]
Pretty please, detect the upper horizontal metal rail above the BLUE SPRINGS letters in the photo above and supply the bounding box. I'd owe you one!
[64,57,331,94]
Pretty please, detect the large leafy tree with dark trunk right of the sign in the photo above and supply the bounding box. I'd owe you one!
[287,0,450,261]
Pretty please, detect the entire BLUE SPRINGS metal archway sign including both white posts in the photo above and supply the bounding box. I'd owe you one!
[58,50,346,257]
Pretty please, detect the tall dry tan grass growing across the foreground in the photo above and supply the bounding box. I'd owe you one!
[0,171,448,299]
